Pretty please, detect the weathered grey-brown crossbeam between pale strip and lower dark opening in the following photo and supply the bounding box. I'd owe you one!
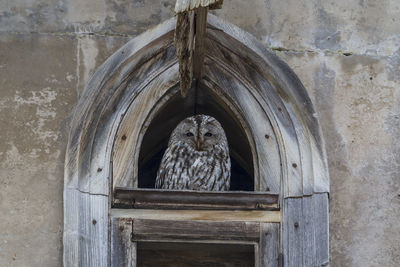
[133,219,260,242]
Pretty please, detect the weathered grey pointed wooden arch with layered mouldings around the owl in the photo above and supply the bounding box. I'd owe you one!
[63,15,329,266]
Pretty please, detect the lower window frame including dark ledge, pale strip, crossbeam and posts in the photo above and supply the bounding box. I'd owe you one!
[111,188,281,267]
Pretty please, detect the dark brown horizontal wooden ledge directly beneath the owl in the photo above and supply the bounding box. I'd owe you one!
[114,188,279,210]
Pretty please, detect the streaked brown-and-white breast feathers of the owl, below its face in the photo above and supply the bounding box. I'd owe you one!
[156,143,231,191]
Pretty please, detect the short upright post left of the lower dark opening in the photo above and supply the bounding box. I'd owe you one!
[111,218,137,267]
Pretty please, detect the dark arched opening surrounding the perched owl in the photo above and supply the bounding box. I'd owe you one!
[138,87,254,191]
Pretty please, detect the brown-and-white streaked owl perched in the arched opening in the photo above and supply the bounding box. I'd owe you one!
[155,115,231,191]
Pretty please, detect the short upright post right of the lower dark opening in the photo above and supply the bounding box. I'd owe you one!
[259,223,280,267]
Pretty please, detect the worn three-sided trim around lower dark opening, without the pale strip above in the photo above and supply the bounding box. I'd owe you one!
[111,218,280,267]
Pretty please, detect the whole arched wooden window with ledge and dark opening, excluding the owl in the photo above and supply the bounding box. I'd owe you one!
[64,16,329,266]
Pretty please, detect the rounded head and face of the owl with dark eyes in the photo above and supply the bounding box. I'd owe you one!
[169,115,227,152]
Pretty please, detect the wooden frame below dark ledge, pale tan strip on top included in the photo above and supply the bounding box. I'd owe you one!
[111,210,281,267]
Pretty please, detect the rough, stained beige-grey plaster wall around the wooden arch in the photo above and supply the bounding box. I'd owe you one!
[0,0,400,266]
